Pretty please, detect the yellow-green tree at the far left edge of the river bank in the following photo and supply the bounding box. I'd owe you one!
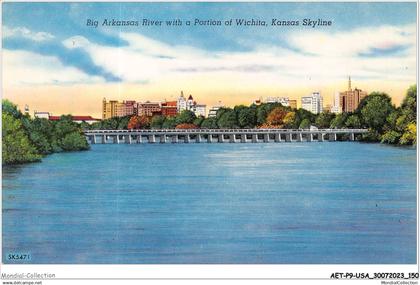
[2,112,41,165]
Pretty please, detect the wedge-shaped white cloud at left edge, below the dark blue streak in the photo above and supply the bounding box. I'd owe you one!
[2,49,104,87]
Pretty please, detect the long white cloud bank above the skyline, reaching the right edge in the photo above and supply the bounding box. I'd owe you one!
[58,22,416,84]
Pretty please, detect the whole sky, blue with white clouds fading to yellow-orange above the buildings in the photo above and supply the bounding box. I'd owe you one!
[2,2,416,118]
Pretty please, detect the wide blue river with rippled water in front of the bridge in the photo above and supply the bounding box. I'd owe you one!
[2,142,417,264]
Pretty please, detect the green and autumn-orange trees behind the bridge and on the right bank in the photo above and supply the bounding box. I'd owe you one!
[84,85,417,145]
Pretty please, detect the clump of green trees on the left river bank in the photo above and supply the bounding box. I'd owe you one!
[2,100,89,165]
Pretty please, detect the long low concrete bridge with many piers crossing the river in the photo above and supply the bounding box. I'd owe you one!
[84,129,367,144]
